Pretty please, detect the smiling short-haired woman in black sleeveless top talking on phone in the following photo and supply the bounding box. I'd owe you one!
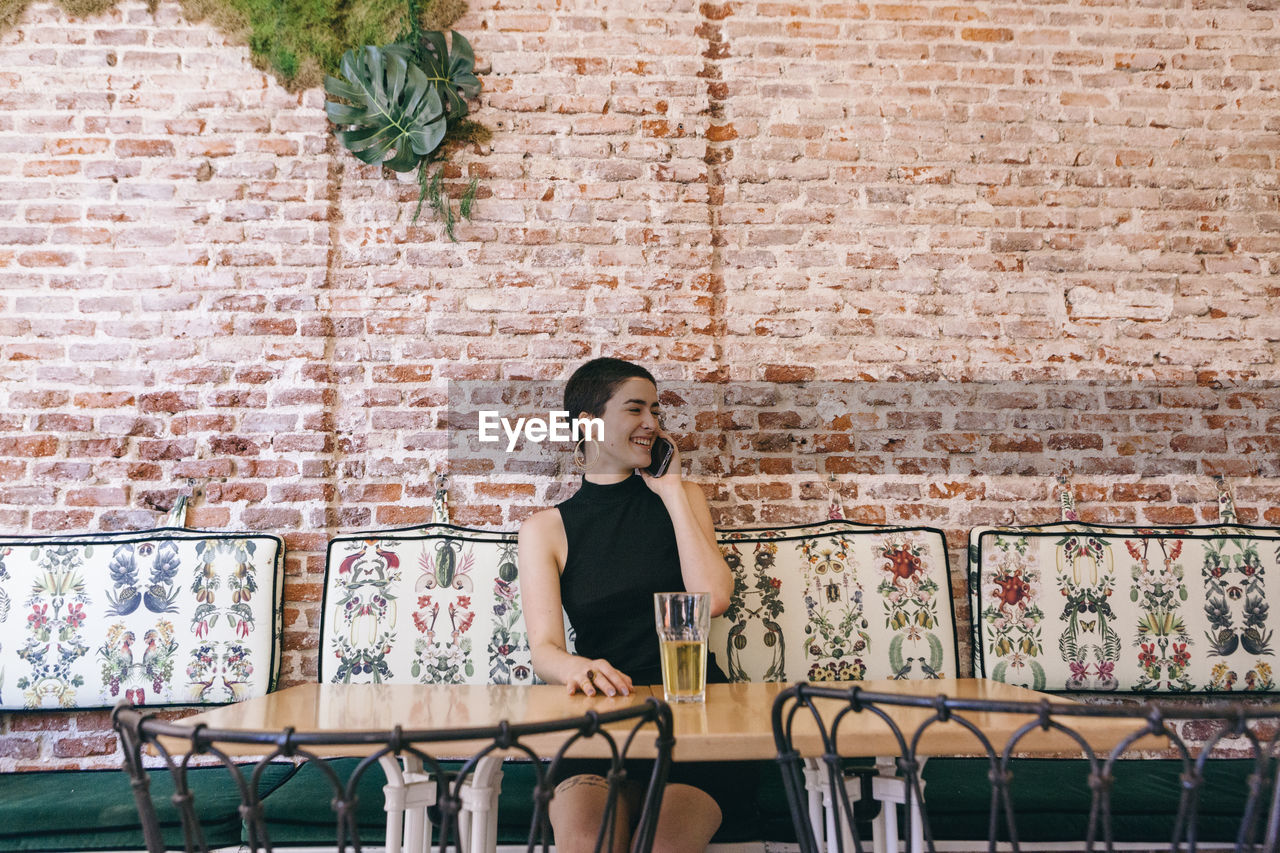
[520,359,733,853]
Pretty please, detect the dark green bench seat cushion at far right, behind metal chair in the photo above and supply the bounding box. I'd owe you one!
[923,758,1253,844]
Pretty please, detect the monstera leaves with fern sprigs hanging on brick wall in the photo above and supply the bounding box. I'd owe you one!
[324,0,488,240]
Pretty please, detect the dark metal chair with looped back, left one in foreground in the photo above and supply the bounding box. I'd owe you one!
[111,698,675,853]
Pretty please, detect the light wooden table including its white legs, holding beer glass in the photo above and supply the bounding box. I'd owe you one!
[165,679,1164,853]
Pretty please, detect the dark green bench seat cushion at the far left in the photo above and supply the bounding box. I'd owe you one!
[0,763,294,852]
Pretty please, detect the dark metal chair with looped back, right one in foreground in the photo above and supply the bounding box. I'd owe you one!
[772,684,1280,853]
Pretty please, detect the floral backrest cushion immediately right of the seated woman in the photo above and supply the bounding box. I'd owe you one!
[710,520,957,681]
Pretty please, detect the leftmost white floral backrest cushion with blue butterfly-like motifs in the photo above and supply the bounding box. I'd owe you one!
[0,528,284,710]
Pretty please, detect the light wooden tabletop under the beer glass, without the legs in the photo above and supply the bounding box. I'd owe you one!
[170,679,1160,761]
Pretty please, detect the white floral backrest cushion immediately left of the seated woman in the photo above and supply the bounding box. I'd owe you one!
[320,524,545,684]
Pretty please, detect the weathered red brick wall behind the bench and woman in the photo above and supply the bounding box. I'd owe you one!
[0,0,1280,768]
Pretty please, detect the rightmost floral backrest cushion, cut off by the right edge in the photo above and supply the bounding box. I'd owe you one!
[969,523,1280,693]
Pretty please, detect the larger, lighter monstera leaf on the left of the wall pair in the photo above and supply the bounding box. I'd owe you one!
[324,40,448,172]
